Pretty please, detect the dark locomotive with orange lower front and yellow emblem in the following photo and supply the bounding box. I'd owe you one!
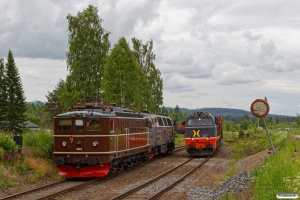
[185,112,223,156]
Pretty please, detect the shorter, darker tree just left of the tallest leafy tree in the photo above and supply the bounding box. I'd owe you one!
[43,80,65,128]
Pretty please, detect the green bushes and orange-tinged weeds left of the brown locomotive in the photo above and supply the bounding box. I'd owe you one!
[0,131,60,188]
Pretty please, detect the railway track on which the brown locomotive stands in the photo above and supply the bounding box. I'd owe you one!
[0,146,184,200]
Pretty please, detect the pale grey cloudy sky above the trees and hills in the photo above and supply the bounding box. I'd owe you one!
[0,0,300,116]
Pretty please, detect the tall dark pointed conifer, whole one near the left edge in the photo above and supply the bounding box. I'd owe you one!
[4,51,26,134]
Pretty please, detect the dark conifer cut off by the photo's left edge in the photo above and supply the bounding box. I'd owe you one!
[0,58,7,132]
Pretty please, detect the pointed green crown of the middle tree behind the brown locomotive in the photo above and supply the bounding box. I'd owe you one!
[103,37,145,109]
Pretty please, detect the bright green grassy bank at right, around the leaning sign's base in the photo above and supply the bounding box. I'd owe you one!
[221,129,300,200]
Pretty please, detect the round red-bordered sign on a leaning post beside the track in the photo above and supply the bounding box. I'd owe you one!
[250,99,276,155]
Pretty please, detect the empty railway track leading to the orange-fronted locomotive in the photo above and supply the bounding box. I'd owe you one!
[111,151,214,200]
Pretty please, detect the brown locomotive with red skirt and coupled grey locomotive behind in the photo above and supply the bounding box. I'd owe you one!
[54,99,175,177]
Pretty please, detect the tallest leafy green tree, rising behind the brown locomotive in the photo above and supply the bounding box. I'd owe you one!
[62,5,110,106]
